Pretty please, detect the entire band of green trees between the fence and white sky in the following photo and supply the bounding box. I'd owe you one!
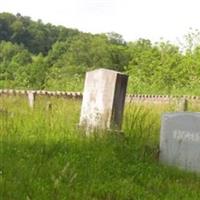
[0,13,200,94]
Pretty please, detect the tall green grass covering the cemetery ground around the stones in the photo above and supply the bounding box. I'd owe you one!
[0,96,200,200]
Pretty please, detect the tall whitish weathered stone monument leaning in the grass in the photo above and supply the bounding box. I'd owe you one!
[79,69,128,133]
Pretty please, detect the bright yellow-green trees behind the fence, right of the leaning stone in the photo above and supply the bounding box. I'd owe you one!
[128,40,200,94]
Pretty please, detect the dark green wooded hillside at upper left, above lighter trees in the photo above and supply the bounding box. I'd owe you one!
[0,13,79,54]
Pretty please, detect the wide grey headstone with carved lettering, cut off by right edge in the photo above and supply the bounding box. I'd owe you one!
[160,112,200,172]
